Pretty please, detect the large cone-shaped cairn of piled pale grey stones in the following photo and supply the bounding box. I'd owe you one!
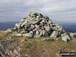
[7,12,71,42]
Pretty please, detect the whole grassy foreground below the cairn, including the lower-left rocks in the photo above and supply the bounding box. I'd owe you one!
[0,31,76,57]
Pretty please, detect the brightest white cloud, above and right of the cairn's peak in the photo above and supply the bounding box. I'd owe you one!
[40,1,76,13]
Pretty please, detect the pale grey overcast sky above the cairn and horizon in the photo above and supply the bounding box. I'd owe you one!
[0,0,76,22]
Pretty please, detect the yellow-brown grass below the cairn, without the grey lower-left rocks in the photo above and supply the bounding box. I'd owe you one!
[0,31,76,57]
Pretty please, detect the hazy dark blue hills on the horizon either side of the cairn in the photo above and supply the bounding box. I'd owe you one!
[0,22,76,32]
